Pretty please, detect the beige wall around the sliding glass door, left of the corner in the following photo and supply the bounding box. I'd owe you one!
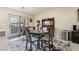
[0,8,32,37]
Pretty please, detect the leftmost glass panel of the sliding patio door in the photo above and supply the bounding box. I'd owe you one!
[9,15,20,36]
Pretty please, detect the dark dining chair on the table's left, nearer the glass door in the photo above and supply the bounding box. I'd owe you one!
[25,27,38,51]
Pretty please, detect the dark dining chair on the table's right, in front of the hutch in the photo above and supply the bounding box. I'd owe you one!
[41,26,54,51]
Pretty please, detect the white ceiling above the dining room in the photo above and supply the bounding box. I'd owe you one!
[10,7,52,16]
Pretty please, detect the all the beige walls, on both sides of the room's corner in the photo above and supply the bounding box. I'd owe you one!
[0,7,79,38]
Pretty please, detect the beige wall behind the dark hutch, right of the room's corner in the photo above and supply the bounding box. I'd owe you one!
[34,7,78,38]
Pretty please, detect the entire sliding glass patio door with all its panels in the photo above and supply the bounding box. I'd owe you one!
[9,15,28,37]
